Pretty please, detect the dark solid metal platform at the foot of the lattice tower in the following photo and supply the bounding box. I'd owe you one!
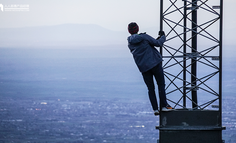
[156,110,225,143]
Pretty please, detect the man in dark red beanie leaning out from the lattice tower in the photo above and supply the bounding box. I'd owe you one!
[128,22,172,115]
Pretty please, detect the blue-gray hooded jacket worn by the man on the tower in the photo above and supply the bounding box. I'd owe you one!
[128,33,166,72]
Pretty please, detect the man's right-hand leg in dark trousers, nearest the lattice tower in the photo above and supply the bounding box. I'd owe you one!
[152,63,168,107]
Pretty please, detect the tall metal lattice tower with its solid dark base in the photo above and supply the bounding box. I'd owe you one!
[158,0,224,143]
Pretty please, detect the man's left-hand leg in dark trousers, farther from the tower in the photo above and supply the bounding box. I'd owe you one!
[142,70,158,111]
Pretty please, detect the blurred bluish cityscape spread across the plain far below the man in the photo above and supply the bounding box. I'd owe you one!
[0,95,236,143]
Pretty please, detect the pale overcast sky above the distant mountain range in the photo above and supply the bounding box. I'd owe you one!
[0,0,236,45]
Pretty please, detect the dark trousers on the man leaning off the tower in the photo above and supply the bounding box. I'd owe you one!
[142,63,167,110]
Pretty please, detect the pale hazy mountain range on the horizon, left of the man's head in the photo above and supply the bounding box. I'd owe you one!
[0,24,129,47]
